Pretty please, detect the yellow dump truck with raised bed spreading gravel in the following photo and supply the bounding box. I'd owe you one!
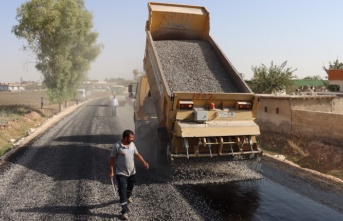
[133,2,262,161]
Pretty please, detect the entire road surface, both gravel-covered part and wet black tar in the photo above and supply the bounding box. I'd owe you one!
[0,98,343,221]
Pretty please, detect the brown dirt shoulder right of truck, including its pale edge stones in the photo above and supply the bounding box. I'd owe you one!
[261,132,343,187]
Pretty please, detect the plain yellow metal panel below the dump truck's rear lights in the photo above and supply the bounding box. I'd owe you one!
[174,120,260,137]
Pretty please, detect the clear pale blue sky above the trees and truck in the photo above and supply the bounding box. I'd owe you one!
[0,0,343,82]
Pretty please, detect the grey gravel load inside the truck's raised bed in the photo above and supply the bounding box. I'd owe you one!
[154,40,238,93]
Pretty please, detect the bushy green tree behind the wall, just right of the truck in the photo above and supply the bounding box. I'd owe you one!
[249,61,297,94]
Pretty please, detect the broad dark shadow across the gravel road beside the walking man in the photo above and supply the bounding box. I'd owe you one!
[6,135,165,185]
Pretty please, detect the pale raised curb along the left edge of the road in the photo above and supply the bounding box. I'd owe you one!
[0,100,90,166]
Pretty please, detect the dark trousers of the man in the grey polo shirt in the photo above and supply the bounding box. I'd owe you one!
[116,175,136,214]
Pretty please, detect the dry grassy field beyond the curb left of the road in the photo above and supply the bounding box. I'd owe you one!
[0,90,110,157]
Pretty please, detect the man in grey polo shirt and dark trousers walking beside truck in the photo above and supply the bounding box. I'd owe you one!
[109,130,149,220]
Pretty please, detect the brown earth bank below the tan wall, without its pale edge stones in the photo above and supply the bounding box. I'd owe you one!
[261,132,343,180]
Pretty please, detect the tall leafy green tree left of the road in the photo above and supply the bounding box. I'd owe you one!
[12,0,102,109]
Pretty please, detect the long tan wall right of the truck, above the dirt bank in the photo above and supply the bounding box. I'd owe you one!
[256,95,343,140]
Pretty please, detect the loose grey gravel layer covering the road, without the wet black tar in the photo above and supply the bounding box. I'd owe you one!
[0,99,342,220]
